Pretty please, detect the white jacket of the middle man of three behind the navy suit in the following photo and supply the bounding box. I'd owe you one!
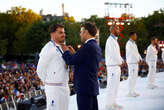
[126,39,142,64]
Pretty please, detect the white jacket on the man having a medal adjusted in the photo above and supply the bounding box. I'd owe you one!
[37,41,69,84]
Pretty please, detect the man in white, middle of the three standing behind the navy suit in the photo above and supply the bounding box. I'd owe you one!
[126,32,142,97]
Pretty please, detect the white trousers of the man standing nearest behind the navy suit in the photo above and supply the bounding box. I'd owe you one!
[105,66,121,106]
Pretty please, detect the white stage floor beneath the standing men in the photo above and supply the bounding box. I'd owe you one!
[69,72,164,110]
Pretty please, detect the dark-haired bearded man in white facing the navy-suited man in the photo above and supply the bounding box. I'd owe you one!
[37,24,70,110]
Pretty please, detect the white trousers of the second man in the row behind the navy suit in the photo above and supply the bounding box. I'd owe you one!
[128,64,138,93]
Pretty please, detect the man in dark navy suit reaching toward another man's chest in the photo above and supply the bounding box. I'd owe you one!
[62,23,101,110]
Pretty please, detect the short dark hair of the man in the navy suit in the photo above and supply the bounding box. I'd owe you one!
[81,22,97,36]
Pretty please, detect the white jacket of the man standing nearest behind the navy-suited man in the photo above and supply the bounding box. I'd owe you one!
[105,35,123,66]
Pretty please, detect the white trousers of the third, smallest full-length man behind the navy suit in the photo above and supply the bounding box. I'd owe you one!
[147,62,157,85]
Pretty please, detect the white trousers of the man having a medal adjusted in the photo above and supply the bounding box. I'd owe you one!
[45,85,70,110]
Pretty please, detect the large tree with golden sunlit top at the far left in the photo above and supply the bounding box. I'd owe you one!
[0,7,41,55]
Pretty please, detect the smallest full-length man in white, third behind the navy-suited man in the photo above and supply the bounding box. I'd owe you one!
[146,37,158,89]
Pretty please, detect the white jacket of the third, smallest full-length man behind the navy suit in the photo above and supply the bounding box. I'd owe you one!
[146,44,158,63]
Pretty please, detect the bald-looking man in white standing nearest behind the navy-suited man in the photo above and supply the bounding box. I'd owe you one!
[105,25,125,110]
